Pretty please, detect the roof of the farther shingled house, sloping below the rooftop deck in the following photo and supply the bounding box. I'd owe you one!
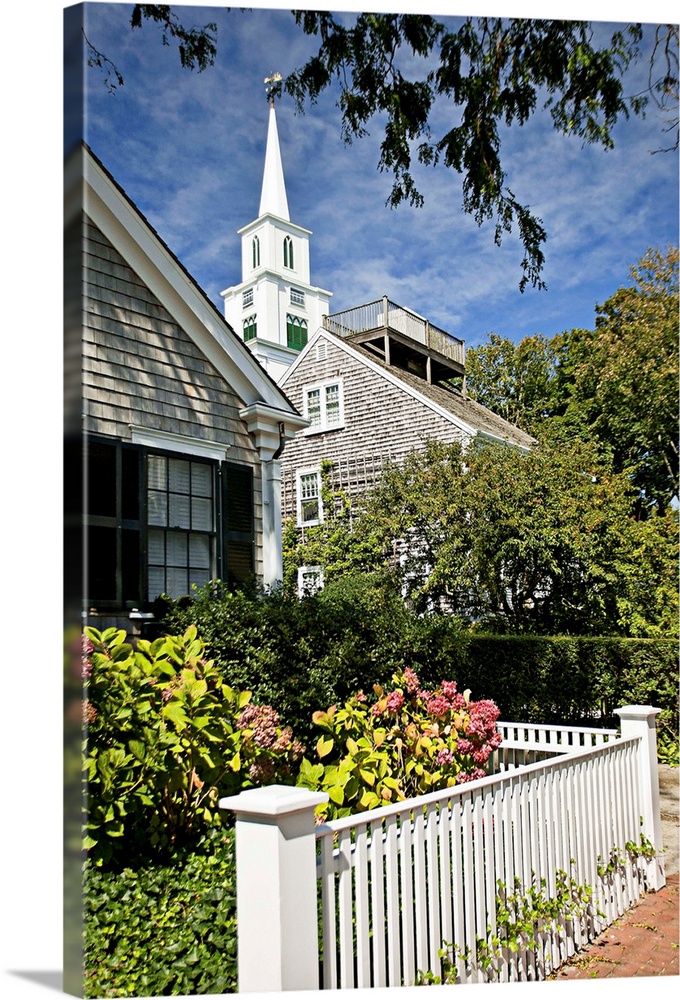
[281,330,536,449]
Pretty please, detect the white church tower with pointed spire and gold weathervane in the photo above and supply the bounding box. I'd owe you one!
[222,82,331,382]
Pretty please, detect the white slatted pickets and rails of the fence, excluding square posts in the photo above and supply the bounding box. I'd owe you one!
[308,723,660,989]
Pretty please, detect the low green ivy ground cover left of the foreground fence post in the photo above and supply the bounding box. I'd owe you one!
[84,830,237,997]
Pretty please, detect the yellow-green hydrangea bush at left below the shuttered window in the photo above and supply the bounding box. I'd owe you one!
[83,626,303,864]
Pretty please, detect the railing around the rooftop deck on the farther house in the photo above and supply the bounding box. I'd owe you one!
[323,297,465,376]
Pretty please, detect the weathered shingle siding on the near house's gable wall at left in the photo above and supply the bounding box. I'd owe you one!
[77,219,262,575]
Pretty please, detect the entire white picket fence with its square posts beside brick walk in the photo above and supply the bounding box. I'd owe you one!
[220,706,665,992]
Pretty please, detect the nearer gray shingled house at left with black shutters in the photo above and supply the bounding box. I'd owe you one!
[64,145,306,631]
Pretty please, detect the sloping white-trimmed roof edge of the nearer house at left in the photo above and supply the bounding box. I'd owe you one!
[64,143,307,434]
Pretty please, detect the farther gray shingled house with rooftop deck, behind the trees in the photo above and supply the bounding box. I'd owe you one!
[279,298,535,589]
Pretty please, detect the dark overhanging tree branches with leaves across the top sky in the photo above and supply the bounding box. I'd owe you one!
[82,4,678,290]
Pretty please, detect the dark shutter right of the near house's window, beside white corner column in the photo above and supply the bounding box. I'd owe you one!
[222,462,255,587]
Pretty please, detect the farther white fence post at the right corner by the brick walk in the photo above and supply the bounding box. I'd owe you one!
[614,705,666,889]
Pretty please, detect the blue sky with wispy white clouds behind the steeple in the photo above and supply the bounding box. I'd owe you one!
[75,3,678,346]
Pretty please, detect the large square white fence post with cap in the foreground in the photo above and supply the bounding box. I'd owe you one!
[219,785,328,993]
